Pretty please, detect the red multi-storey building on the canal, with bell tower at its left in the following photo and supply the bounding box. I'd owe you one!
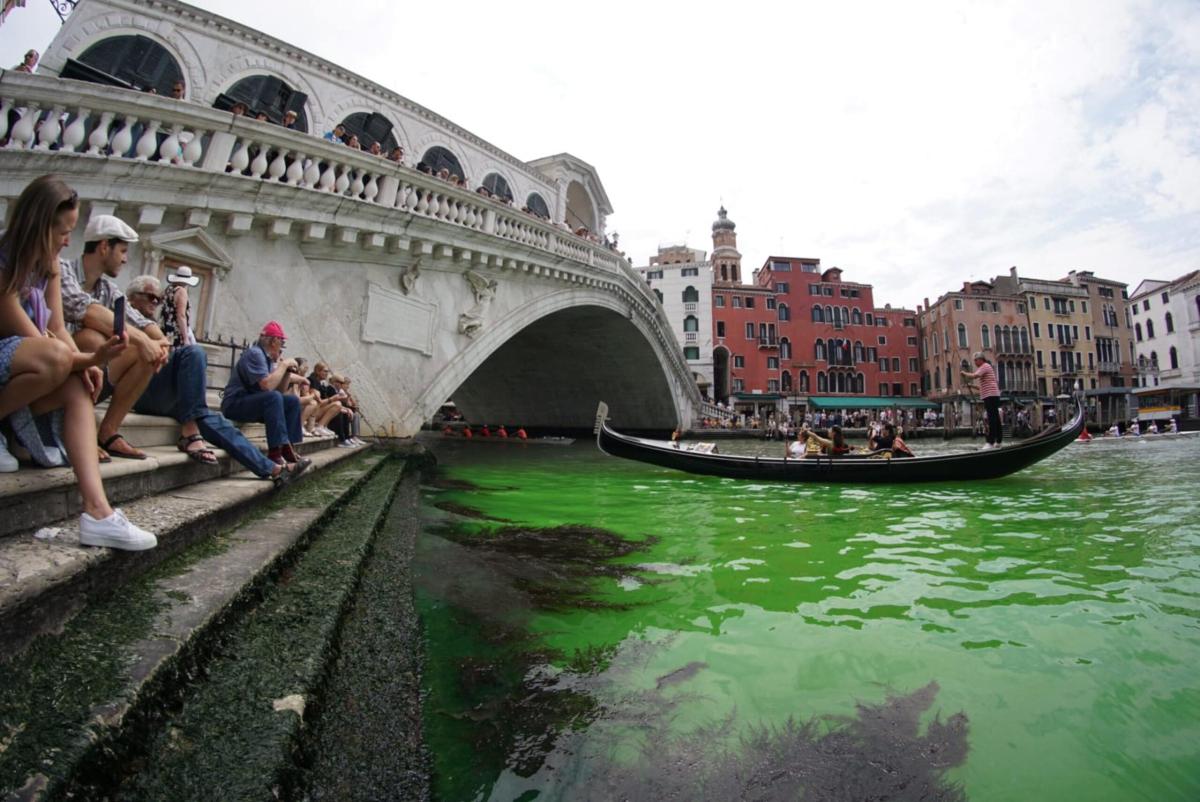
[712,209,920,414]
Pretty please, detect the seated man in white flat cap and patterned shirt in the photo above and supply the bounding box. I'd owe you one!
[60,215,167,461]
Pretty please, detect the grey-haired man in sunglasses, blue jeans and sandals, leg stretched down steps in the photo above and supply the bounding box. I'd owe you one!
[128,275,292,486]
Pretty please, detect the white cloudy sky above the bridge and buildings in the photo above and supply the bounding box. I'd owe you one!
[0,0,1200,306]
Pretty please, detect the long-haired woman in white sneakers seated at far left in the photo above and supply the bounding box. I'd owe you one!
[0,175,158,551]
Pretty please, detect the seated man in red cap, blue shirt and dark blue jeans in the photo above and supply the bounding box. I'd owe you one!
[221,321,311,474]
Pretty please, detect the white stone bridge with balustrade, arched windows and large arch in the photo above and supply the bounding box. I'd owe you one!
[0,0,702,435]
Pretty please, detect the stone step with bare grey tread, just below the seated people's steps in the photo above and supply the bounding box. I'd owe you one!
[0,451,400,800]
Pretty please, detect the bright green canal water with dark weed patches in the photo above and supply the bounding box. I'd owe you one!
[416,437,1200,802]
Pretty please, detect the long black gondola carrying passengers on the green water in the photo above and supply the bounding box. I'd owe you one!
[595,396,1084,484]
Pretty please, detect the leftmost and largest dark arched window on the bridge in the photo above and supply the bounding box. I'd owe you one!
[61,35,184,97]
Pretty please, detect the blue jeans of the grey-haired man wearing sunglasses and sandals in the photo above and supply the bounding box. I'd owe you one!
[133,346,275,478]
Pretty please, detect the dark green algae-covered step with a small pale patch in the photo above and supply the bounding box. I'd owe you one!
[76,461,402,802]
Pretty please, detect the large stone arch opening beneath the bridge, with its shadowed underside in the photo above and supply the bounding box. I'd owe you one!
[406,289,691,431]
